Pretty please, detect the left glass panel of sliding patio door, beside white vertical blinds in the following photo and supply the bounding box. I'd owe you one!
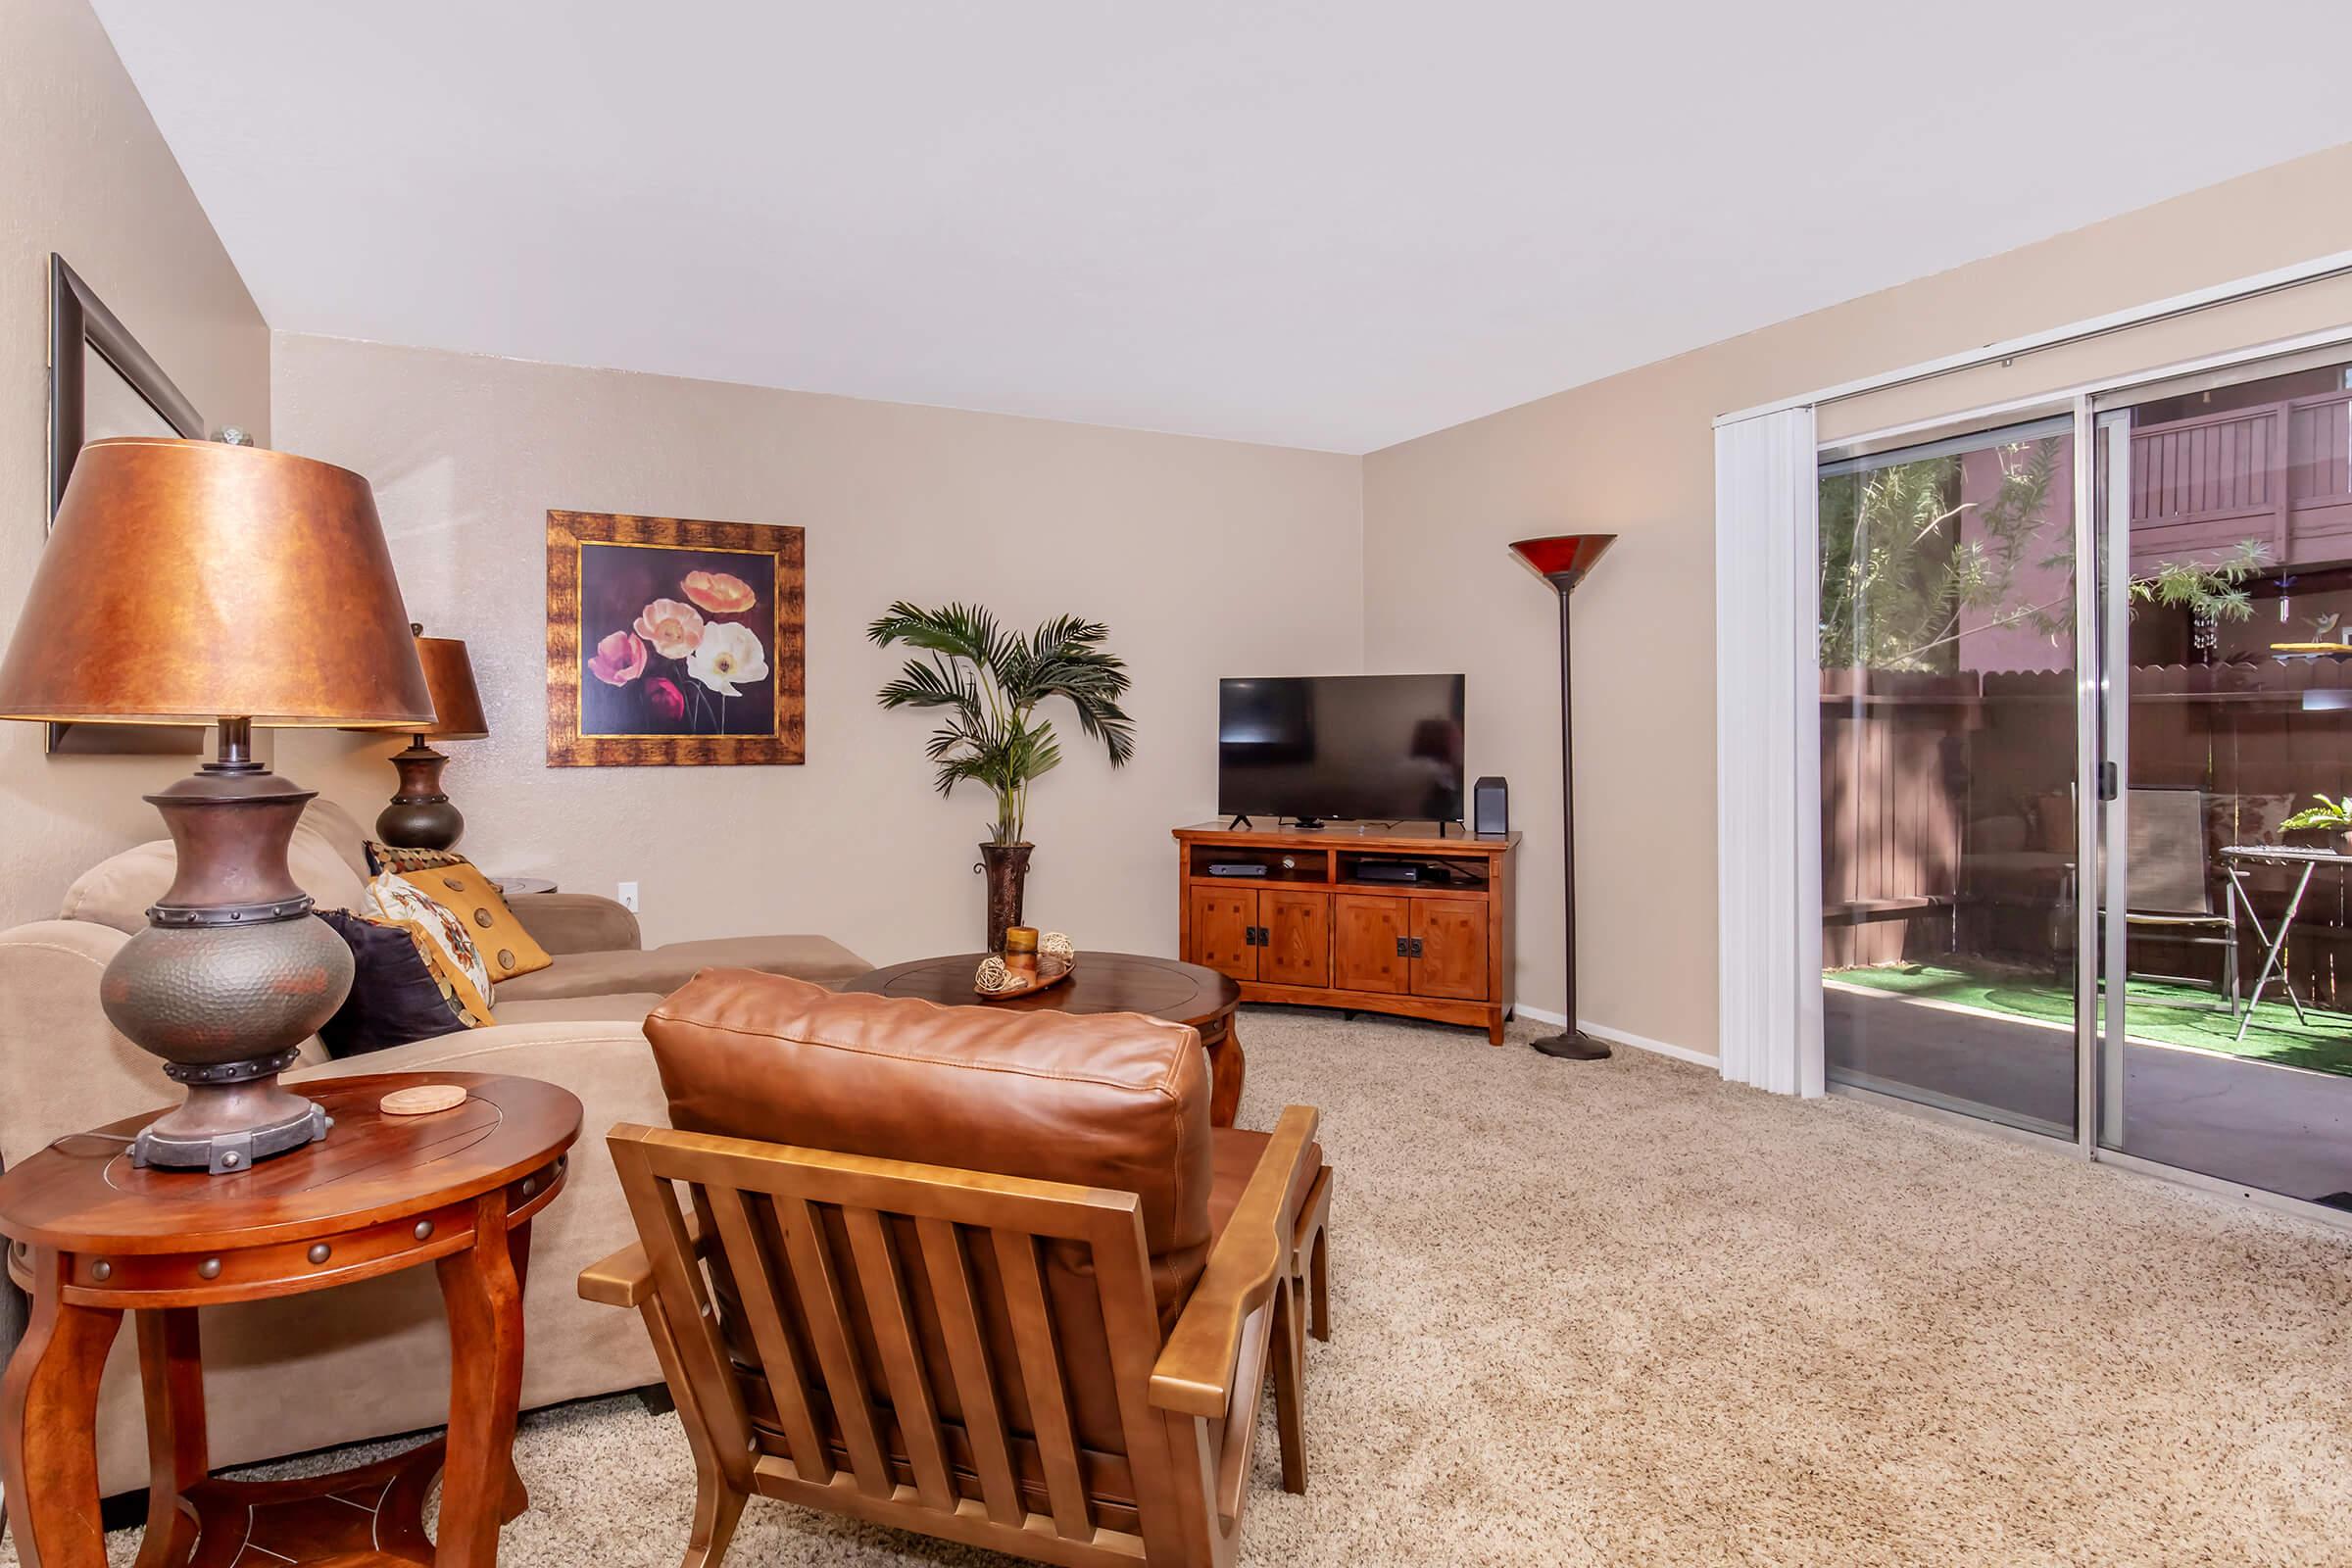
[1816,416,2086,1140]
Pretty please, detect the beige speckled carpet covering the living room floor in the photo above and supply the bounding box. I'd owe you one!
[18,1008,2352,1568]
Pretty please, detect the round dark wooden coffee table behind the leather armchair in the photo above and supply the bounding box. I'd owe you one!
[842,953,1249,1126]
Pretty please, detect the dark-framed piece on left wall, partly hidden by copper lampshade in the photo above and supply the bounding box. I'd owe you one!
[42,252,205,757]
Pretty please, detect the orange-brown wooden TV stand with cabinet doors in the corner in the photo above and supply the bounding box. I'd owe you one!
[1174,823,1519,1046]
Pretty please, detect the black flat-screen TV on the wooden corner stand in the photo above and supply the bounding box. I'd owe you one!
[1216,674,1463,825]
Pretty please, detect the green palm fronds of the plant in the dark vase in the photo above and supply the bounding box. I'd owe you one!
[865,600,1136,844]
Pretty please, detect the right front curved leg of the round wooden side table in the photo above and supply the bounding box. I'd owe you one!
[433,1190,522,1568]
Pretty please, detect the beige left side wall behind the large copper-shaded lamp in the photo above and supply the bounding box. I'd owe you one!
[0,0,270,926]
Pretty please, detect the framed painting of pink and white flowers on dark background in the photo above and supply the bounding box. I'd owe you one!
[548,513,807,766]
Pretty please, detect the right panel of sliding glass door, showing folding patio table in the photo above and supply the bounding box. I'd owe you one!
[2093,350,2352,1208]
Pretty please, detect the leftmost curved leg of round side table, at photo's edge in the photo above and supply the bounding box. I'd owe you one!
[0,1249,122,1568]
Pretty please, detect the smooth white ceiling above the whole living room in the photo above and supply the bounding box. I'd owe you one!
[96,0,2352,452]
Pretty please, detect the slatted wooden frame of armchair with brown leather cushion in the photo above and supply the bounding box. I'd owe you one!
[578,1104,1329,1568]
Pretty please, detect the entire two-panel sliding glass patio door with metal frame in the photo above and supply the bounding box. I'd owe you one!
[1813,348,2352,1210]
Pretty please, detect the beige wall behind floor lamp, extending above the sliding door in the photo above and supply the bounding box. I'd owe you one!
[1364,148,2352,1054]
